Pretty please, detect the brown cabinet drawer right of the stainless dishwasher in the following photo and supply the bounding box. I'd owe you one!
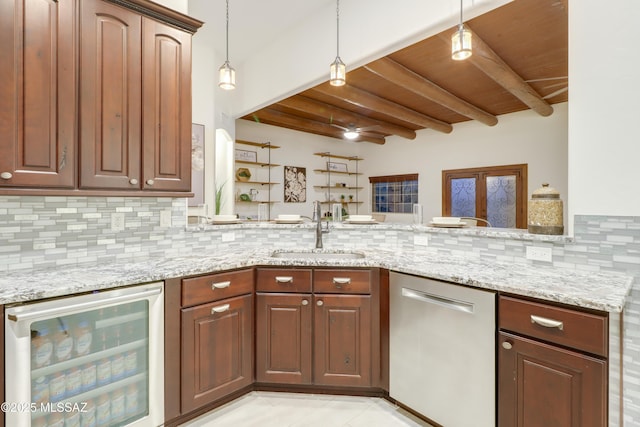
[499,296,609,357]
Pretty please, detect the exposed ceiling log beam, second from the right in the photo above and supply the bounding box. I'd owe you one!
[364,57,498,126]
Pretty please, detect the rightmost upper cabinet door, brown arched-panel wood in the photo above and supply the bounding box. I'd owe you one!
[142,18,191,191]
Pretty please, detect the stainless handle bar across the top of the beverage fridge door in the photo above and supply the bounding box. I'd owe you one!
[7,286,162,323]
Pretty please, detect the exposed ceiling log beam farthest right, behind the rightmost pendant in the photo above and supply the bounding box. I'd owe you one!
[440,26,553,117]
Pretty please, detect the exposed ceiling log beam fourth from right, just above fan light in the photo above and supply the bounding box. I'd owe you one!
[278,96,416,139]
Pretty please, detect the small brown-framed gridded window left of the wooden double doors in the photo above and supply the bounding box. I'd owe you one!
[369,173,418,213]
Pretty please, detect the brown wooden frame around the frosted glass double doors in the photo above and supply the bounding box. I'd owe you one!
[442,163,528,229]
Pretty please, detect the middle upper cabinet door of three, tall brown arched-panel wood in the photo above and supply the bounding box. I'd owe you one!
[80,0,141,190]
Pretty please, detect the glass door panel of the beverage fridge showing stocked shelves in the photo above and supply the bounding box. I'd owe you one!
[31,300,149,426]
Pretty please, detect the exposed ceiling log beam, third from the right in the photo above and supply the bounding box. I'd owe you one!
[309,84,453,133]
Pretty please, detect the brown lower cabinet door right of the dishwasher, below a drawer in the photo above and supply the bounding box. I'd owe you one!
[498,332,608,427]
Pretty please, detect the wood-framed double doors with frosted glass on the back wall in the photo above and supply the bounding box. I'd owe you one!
[442,164,527,228]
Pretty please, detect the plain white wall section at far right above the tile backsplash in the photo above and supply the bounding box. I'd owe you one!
[569,0,640,224]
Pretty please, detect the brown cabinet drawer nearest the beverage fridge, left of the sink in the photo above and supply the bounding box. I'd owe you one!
[182,270,253,307]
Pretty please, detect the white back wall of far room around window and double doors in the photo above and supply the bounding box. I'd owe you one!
[363,104,568,224]
